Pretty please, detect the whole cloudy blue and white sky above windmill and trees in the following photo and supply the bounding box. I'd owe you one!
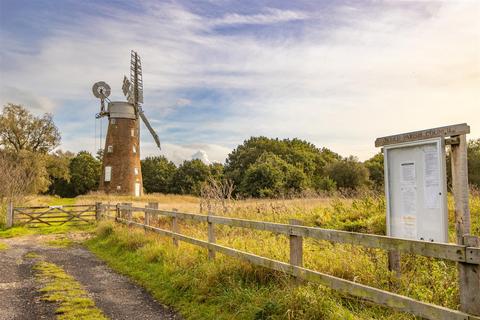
[0,0,480,164]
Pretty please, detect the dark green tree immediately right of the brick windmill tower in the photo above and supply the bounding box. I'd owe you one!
[141,156,177,193]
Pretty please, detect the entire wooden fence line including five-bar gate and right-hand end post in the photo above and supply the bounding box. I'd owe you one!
[7,201,480,320]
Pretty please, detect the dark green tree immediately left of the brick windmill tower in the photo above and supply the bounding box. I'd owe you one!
[70,151,101,196]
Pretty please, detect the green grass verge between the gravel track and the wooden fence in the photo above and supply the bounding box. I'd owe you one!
[86,223,414,320]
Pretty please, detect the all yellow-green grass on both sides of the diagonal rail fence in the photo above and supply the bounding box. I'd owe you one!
[1,194,480,319]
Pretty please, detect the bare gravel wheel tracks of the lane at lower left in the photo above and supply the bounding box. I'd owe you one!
[0,235,181,320]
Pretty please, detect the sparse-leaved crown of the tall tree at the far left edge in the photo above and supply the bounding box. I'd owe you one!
[0,103,60,153]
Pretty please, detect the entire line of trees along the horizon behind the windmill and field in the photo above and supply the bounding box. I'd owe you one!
[0,104,480,197]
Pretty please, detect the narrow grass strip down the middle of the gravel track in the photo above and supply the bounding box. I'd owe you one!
[34,261,107,320]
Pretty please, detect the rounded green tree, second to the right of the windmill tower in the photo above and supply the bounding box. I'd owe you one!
[173,159,210,196]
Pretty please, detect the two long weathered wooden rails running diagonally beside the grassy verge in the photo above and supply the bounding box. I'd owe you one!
[102,205,480,320]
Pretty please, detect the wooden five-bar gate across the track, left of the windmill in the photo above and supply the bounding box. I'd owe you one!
[7,204,98,227]
